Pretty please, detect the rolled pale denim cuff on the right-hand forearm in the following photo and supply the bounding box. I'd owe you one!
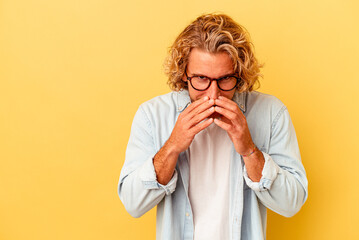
[243,152,279,191]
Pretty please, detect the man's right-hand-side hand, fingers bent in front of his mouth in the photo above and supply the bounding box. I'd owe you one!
[214,96,255,155]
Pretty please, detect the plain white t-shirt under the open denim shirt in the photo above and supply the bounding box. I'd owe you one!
[188,123,232,240]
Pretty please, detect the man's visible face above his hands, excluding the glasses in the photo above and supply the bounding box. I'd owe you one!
[184,48,236,102]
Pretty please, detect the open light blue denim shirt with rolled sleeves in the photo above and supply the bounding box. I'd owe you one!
[118,90,308,240]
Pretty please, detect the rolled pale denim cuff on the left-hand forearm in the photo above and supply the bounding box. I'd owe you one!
[139,157,177,195]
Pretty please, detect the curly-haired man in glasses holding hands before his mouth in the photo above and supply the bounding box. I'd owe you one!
[118,14,308,240]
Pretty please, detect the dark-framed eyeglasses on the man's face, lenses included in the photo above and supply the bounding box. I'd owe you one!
[185,71,241,91]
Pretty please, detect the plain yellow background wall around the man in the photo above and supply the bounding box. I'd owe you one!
[0,0,359,240]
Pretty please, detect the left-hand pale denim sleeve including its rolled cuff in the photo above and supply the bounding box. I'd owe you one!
[118,105,177,217]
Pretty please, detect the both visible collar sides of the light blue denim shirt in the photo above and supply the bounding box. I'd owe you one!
[177,89,247,112]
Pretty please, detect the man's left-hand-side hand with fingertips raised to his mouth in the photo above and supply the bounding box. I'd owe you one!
[166,96,214,154]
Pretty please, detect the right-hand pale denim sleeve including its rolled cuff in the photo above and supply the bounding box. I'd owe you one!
[243,106,308,217]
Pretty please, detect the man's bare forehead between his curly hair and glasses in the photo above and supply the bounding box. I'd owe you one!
[187,48,234,77]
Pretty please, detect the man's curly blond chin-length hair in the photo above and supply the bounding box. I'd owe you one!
[164,14,262,92]
